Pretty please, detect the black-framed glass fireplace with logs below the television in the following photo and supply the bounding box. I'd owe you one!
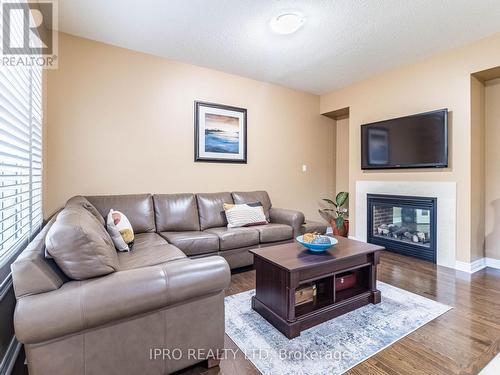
[367,194,437,263]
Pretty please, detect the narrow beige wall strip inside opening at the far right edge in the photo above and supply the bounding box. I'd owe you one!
[485,79,500,259]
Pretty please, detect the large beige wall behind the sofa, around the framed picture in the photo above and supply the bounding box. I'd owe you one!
[44,34,335,222]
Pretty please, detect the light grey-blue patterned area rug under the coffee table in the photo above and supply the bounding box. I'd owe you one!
[225,282,451,375]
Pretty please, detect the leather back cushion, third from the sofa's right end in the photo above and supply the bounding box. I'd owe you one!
[153,194,200,232]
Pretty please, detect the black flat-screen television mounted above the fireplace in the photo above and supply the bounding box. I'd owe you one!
[361,109,448,169]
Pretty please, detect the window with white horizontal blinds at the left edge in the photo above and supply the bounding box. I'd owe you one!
[0,2,43,265]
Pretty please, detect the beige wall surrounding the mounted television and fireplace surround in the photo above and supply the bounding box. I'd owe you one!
[321,34,500,262]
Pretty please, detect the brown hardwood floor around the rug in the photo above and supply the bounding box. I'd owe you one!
[178,252,500,375]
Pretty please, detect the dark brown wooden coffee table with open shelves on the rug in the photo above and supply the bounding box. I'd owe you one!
[250,237,384,338]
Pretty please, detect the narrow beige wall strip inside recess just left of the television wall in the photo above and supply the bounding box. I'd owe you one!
[335,117,349,193]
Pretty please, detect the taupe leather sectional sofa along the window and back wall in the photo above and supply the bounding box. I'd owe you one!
[12,191,320,375]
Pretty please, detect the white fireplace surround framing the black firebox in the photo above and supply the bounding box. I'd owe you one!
[355,181,457,268]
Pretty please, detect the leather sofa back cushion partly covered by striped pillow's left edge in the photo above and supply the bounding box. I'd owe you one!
[196,193,233,230]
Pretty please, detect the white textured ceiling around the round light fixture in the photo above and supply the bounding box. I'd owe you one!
[59,0,500,94]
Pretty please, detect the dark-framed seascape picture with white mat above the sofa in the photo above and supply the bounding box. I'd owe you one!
[194,101,247,164]
